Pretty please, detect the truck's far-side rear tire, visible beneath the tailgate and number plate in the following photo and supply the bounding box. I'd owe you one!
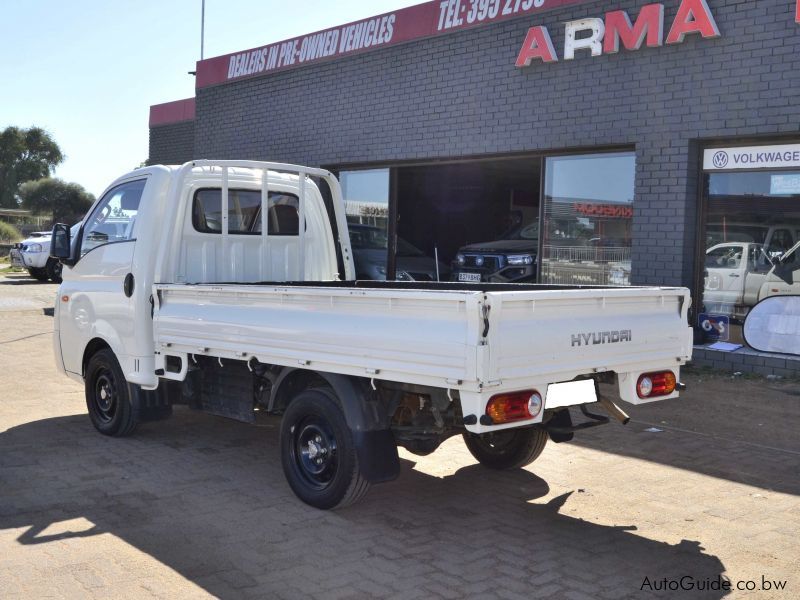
[463,427,548,471]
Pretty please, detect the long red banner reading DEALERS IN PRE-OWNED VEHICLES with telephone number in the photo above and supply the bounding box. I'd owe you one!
[197,0,589,88]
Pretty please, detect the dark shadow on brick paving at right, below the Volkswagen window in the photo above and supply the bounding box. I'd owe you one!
[572,373,800,495]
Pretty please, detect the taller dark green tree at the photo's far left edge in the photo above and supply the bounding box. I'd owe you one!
[0,127,64,208]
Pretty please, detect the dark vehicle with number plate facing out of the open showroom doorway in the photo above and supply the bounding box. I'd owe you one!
[452,221,539,283]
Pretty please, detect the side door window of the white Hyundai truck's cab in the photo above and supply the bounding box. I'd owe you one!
[81,179,146,256]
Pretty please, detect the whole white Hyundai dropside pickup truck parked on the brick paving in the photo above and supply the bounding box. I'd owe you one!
[52,161,692,509]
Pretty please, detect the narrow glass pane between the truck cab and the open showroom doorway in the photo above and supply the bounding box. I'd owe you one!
[339,169,389,279]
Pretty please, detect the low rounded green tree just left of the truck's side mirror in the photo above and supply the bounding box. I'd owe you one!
[19,178,94,224]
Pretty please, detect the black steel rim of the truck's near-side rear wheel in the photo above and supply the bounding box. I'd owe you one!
[292,417,339,490]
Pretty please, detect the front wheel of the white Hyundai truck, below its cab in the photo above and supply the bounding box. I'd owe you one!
[85,348,139,437]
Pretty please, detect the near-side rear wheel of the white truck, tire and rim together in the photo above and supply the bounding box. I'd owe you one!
[280,388,369,510]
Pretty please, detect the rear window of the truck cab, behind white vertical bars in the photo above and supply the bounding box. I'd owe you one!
[192,189,299,235]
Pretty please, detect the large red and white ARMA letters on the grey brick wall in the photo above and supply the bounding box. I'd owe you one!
[516,0,720,67]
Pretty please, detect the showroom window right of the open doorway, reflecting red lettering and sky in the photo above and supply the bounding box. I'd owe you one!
[540,152,636,285]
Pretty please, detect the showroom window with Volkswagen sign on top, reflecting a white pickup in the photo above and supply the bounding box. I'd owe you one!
[697,152,800,349]
